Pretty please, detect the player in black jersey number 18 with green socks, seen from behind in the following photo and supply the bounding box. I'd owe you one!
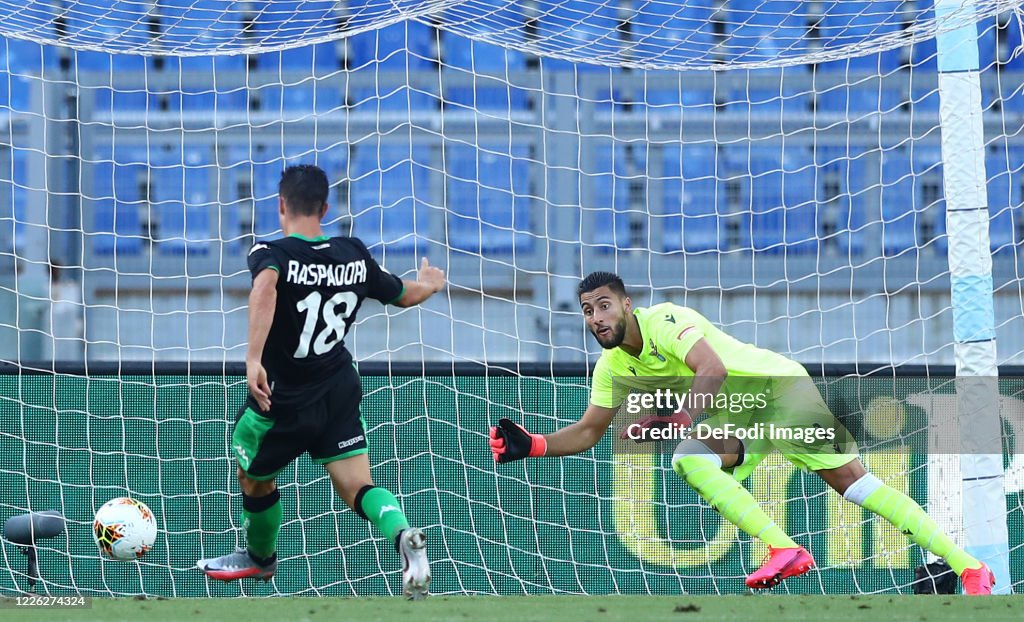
[198,165,444,598]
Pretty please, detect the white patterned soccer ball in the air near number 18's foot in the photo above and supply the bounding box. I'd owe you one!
[92,497,157,561]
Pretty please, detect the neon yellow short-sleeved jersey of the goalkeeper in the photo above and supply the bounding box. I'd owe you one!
[590,302,808,408]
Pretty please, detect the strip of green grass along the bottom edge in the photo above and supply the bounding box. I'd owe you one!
[0,594,1024,622]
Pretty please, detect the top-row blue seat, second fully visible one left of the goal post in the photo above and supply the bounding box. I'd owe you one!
[726,0,808,64]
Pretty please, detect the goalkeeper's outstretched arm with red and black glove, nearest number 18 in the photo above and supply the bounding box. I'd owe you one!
[490,404,616,463]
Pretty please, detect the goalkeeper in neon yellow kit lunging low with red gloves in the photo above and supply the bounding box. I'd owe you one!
[490,272,994,594]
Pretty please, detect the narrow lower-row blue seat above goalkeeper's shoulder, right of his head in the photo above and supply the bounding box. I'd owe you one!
[652,144,720,253]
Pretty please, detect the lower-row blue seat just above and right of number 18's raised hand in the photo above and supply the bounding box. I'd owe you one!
[445,144,532,254]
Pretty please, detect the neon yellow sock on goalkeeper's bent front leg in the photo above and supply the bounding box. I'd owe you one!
[672,455,798,548]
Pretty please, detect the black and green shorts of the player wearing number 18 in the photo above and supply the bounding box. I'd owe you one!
[231,365,367,481]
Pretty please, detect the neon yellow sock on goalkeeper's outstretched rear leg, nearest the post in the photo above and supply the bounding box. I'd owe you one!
[843,473,981,575]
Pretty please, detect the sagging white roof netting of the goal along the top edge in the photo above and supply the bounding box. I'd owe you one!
[0,0,1020,70]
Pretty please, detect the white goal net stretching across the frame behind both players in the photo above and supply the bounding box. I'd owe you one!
[0,0,1024,596]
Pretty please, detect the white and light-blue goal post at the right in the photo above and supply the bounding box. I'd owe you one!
[929,0,1012,593]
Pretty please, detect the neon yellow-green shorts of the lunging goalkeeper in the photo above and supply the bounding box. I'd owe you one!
[698,376,859,482]
